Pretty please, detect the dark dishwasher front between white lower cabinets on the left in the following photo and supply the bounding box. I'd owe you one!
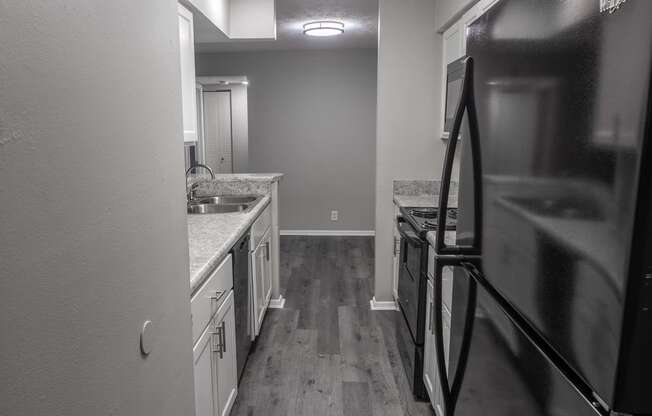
[231,231,252,381]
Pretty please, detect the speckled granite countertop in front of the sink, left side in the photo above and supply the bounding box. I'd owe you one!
[187,194,273,294]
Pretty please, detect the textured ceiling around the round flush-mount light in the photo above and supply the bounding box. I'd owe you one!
[195,0,378,53]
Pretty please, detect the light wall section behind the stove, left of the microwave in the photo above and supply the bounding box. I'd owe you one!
[374,0,446,301]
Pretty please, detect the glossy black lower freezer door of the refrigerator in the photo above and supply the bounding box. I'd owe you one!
[440,268,600,416]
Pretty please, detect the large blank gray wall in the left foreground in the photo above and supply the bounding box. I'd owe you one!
[0,0,194,416]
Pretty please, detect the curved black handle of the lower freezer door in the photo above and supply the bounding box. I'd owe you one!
[434,260,477,416]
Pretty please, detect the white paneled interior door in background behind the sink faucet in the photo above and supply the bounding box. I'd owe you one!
[204,91,233,173]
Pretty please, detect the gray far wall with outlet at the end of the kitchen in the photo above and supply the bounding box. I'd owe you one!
[196,49,377,230]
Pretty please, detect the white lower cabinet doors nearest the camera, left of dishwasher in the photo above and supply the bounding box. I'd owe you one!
[193,290,238,416]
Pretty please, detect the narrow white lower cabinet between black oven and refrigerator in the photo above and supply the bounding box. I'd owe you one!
[423,278,451,416]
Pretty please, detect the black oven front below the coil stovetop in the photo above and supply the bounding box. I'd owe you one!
[396,217,428,400]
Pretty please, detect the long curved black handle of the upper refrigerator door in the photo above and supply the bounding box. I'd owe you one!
[435,57,482,255]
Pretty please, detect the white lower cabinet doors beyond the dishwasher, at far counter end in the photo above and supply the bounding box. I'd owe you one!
[251,228,273,336]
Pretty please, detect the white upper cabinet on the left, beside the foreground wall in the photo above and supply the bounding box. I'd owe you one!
[177,4,198,142]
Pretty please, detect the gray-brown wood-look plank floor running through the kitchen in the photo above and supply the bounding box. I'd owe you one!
[232,236,432,416]
